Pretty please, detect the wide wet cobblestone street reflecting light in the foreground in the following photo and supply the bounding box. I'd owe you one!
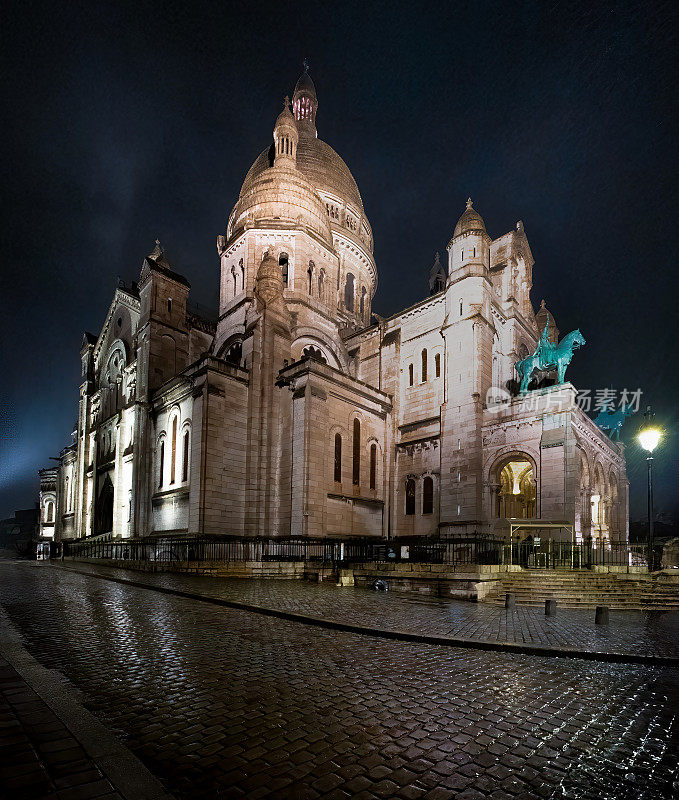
[0,562,679,800]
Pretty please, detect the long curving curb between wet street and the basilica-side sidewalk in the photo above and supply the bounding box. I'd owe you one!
[52,564,679,667]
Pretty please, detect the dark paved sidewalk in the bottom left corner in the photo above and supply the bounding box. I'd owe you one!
[0,657,122,800]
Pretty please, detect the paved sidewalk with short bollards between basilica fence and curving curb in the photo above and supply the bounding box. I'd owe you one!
[59,562,679,657]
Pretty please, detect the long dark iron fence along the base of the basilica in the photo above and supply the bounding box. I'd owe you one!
[63,535,647,569]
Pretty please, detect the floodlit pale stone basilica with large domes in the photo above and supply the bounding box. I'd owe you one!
[40,70,628,547]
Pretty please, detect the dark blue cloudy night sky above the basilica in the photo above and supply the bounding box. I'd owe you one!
[0,0,679,519]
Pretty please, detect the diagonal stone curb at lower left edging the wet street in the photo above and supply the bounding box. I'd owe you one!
[0,600,174,800]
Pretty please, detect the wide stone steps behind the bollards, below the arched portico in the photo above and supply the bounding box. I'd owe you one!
[484,570,679,611]
